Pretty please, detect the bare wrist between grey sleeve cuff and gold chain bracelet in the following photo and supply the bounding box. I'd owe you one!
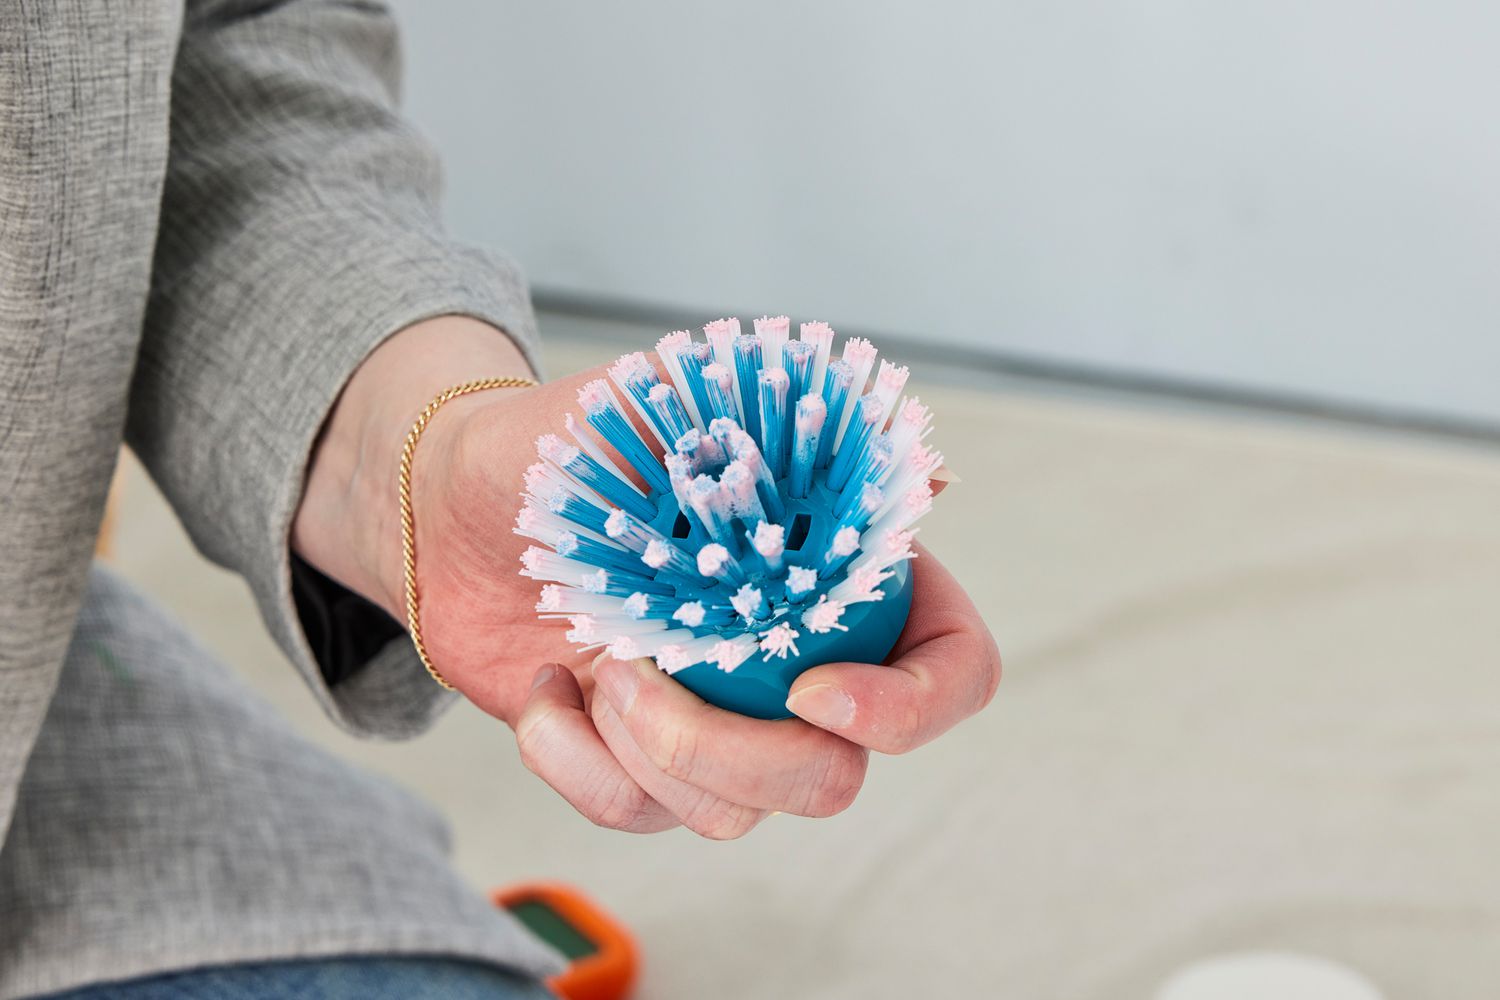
[293,316,536,621]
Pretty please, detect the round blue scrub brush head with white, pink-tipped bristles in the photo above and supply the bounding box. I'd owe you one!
[516,316,942,718]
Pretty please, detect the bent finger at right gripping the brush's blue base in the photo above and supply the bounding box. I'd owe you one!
[786,550,1001,754]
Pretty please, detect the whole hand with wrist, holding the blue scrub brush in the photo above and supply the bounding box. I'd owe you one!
[294,316,999,838]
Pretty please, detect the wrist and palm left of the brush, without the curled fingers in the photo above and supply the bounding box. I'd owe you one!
[293,316,642,724]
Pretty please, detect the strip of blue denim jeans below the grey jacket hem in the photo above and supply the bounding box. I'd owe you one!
[48,957,555,1000]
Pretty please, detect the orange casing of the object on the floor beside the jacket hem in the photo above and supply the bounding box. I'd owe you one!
[491,882,641,1000]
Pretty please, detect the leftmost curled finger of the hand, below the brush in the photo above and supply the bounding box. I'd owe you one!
[516,663,678,834]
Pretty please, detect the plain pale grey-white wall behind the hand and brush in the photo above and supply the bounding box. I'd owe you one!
[396,0,1500,421]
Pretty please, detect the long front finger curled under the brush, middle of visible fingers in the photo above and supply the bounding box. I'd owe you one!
[594,657,869,825]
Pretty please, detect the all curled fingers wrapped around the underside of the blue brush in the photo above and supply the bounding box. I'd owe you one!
[516,546,1001,840]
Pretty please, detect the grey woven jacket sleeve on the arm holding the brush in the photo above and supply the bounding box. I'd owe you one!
[128,0,536,738]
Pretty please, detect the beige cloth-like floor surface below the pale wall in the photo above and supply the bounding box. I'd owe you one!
[108,318,1500,1000]
